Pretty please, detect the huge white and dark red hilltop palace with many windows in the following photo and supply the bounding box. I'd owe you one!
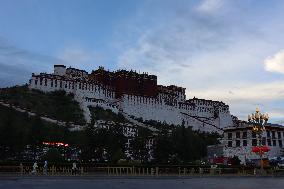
[29,65,233,132]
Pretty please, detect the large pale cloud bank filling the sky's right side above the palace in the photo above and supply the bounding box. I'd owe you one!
[118,1,284,122]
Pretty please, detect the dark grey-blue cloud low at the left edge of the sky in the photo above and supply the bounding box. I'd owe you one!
[0,38,60,87]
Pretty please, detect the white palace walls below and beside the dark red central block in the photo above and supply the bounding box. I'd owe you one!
[29,68,232,132]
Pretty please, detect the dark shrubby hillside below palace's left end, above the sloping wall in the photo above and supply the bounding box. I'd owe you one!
[0,85,85,124]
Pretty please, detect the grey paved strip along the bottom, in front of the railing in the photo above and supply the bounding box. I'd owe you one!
[0,177,284,189]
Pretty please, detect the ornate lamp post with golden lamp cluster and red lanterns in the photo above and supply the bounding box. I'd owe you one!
[248,108,269,173]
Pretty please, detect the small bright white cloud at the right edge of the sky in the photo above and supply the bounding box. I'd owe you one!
[264,50,284,74]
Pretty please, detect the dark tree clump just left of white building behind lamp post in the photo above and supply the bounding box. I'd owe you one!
[154,126,219,164]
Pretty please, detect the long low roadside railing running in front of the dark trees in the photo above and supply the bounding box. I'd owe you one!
[0,164,284,177]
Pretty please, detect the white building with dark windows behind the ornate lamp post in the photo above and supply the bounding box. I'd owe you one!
[207,121,284,164]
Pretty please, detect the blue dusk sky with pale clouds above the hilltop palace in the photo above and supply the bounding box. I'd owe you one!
[0,0,284,124]
